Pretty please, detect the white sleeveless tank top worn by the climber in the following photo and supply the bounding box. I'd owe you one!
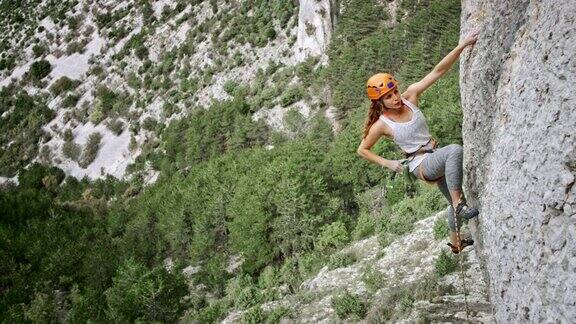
[379,98,431,172]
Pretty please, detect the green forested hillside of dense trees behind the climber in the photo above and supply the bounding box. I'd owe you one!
[0,0,472,323]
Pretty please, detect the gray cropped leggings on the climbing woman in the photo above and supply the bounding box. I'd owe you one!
[412,144,464,231]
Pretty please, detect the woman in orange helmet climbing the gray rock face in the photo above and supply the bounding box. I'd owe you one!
[358,31,478,253]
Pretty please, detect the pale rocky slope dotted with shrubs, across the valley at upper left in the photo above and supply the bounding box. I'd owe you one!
[0,0,334,182]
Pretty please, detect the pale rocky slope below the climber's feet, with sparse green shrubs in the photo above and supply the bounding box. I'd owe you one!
[223,212,494,323]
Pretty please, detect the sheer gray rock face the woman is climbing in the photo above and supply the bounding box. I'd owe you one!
[460,0,576,323]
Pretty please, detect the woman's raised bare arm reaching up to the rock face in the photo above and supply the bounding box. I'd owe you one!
[402,31,478,103]
